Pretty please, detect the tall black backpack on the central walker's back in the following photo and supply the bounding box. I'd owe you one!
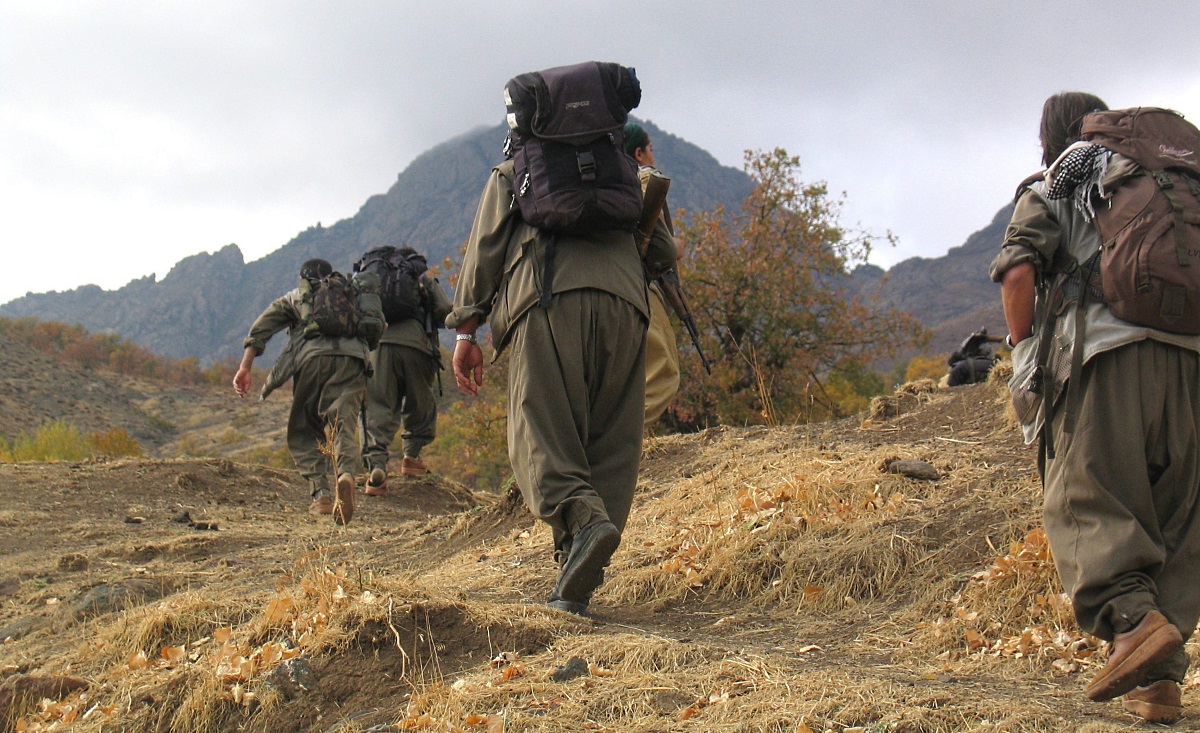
[504,61,642,233]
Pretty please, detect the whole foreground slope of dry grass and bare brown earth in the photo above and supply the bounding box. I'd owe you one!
[0,371,1200,733]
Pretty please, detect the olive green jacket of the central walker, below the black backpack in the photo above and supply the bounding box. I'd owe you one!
[445,161,664,355]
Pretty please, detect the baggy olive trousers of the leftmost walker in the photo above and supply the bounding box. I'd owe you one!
[288,354,367,488]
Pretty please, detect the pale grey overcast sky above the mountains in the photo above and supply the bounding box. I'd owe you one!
[0,0,1200,304]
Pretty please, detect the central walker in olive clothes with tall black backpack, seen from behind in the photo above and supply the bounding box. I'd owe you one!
[446,62,672,614]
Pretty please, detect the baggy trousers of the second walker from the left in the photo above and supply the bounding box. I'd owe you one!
[362,343,438,470]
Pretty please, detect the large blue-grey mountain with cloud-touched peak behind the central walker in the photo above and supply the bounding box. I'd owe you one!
[0,122,750,362]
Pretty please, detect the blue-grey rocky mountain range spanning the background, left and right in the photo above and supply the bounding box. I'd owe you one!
[0,122,1012,371]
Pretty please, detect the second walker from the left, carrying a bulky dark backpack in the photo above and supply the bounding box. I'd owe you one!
[353,246,452,497]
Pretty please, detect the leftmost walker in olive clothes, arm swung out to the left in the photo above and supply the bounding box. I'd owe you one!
[233,259,382,524]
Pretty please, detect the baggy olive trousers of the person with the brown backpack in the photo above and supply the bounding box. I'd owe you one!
[1043,340,1200,681]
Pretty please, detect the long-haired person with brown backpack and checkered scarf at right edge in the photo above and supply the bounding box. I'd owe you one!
[990,92,1200,722]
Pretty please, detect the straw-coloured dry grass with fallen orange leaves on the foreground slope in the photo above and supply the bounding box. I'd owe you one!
[9,381,1200,733]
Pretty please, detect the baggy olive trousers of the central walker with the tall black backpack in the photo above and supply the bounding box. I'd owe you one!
[508,289,646,549]
